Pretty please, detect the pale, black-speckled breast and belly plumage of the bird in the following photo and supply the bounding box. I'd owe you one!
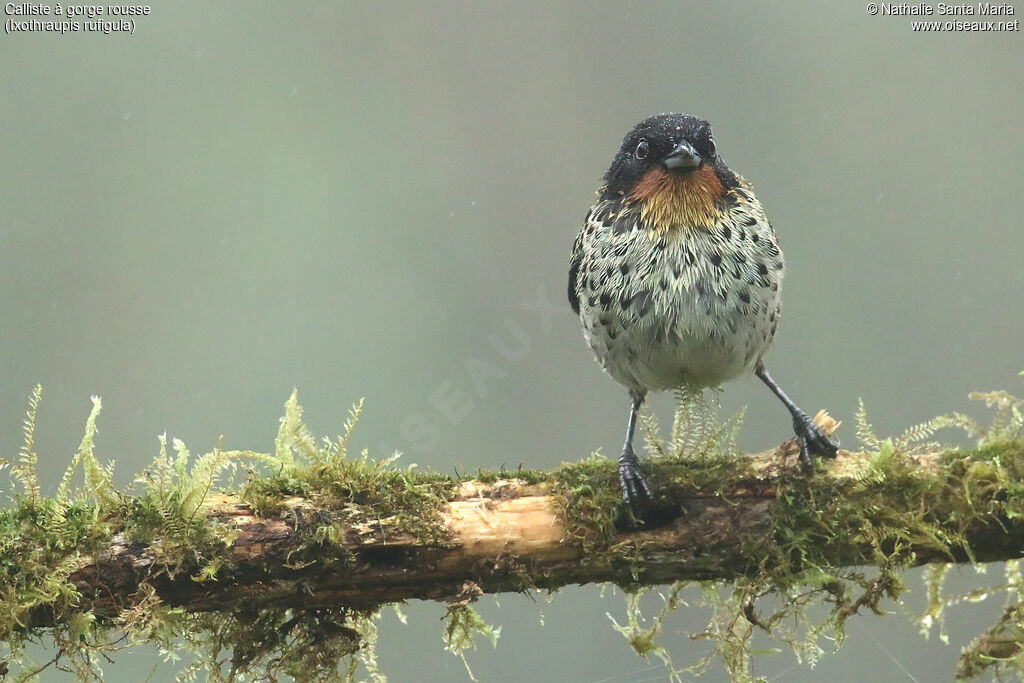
[572,181,784,393]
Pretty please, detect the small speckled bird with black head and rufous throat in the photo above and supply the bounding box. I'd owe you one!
[568,114,840,511]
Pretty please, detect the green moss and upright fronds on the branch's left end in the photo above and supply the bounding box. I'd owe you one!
[0,388,419,681]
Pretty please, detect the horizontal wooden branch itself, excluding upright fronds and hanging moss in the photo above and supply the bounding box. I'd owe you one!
[14,428,1024,626]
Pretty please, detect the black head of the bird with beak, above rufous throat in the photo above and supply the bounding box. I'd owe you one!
[602,114,736,197]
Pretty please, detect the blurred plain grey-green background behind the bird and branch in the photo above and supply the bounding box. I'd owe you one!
[0,1,1024,683]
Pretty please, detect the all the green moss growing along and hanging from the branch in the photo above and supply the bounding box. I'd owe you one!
[6,388,1024,680]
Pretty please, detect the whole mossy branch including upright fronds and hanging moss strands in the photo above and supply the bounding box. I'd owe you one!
[0,389,1024,680]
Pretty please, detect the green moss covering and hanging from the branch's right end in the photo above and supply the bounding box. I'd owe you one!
[602,392,1024,680]
